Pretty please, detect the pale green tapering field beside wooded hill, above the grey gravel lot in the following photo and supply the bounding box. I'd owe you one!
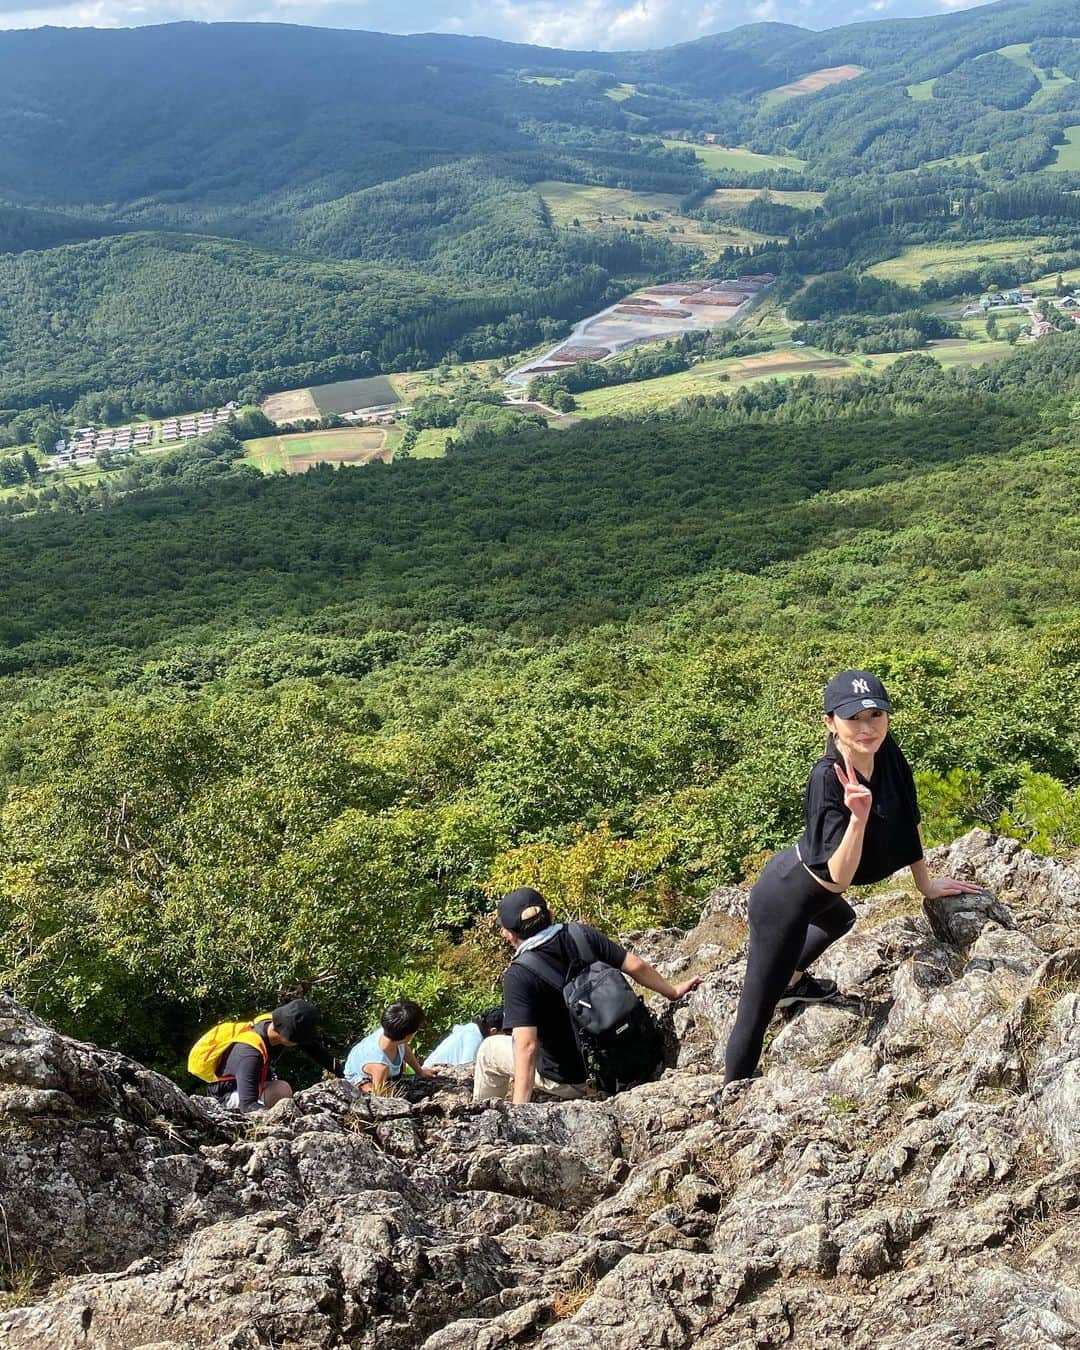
[533,181,765,255]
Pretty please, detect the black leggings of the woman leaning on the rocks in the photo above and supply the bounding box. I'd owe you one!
[724,848,855,1083]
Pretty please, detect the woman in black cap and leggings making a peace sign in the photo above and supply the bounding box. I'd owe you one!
[725,671,979,1083]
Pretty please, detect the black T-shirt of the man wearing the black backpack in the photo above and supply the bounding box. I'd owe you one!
[502,923,626,1083]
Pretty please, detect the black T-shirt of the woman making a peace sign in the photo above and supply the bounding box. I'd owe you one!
[799,733,922,886]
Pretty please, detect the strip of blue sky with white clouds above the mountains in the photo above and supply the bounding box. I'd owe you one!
[0,0,988,51]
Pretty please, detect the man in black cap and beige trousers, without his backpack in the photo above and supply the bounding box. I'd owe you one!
[473,887,701,1106]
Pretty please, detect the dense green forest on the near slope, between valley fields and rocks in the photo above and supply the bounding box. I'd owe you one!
[0,333,1080,1065]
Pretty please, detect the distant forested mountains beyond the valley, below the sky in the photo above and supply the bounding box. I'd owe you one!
[0,0,1080,412]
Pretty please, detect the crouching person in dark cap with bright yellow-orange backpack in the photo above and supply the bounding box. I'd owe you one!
[188,999,342,1111]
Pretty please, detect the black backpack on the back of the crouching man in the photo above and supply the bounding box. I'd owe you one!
[516,923,664,1092]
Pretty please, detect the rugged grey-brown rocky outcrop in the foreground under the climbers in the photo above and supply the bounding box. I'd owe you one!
[0,833,1080,1350]
